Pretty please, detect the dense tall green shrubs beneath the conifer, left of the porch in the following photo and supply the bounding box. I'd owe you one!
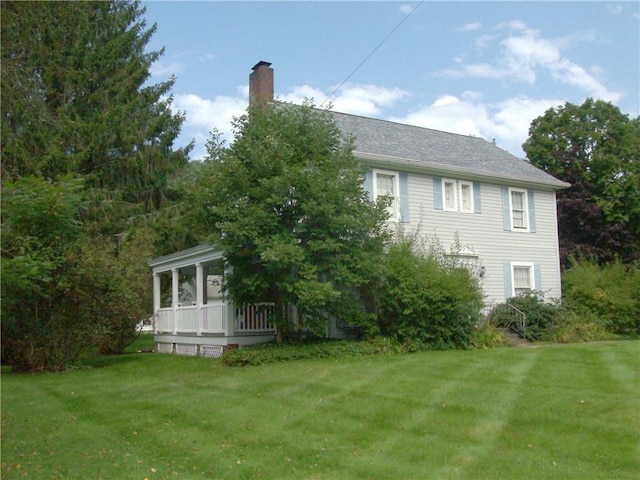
[2,177,151,370]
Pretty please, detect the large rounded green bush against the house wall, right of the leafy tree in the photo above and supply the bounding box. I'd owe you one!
[378,237,482,349]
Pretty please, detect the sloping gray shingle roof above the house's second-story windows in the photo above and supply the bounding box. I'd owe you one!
[331,111,569,189]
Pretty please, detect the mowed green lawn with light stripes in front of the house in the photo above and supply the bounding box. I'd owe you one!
[1,341,640,480]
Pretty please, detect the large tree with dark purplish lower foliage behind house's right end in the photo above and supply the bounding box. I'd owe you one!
[523,98,640,267]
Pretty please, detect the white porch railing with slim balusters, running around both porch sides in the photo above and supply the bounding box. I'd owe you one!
[156,302,275,334]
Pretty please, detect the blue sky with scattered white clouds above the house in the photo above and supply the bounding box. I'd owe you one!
[142,0,640,159]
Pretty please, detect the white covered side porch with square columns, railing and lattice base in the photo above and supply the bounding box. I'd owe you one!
[149,245,276,357]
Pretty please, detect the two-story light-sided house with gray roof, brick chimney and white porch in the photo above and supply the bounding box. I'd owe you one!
[149,62,569,356]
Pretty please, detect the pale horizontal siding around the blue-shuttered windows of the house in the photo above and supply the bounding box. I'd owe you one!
[403,173,561,304]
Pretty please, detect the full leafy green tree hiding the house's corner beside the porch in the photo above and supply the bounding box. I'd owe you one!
[189,103,387,339]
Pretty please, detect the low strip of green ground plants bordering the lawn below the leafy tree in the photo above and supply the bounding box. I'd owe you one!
[222,337,405,367]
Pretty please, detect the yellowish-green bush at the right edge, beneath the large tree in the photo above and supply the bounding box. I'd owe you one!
[562,259,640,335]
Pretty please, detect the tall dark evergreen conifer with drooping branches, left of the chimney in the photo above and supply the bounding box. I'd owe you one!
[1,1,190,233]
